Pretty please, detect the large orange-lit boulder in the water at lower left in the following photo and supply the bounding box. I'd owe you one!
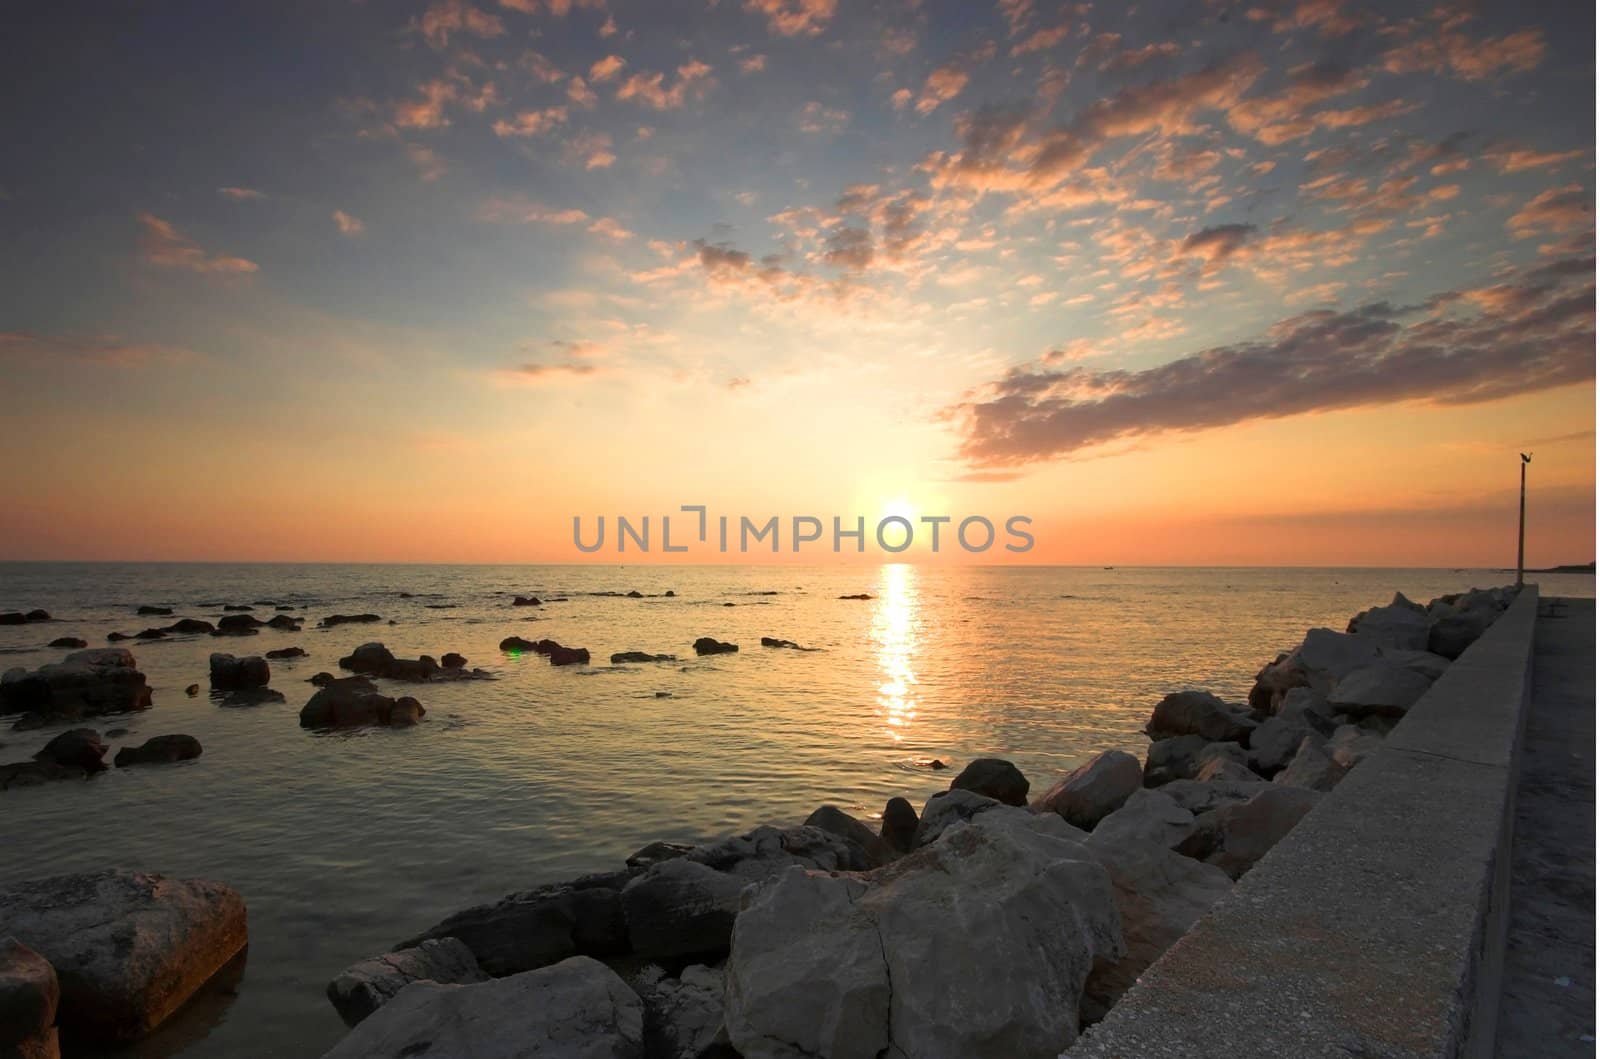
[0,870,246,1041]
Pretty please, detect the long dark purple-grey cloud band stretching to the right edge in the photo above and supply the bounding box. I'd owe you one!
[949,258,1595,467]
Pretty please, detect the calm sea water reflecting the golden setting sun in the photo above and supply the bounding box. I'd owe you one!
[0,563,1594,1057]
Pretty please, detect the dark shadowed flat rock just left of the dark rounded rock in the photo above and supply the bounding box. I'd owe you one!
[395,872,637,977]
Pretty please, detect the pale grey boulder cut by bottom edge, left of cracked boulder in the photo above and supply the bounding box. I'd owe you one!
[323,957,645,1059]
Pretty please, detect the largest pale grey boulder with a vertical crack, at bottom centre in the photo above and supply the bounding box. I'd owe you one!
[726,809,1125,1059]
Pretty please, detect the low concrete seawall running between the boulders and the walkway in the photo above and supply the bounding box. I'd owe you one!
[1066,585,1539,1059]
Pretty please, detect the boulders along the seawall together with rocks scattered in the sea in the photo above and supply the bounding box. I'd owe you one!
[0,589,1514,1057]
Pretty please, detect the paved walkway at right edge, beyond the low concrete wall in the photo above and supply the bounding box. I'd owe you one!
[1496,598,1595,1059]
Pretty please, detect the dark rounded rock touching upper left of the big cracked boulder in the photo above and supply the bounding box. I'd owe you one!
[622,857,746,960]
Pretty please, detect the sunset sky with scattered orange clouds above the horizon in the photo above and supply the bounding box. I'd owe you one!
[0,0,1595,566]
